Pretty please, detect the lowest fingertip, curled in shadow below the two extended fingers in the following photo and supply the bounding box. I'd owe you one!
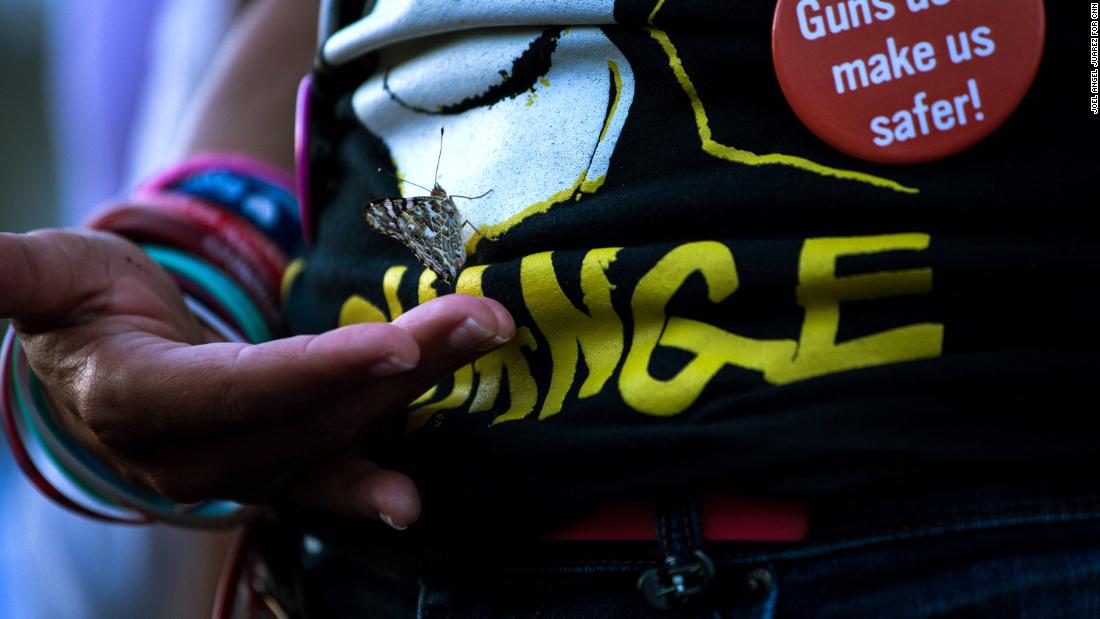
[290,455,420,530]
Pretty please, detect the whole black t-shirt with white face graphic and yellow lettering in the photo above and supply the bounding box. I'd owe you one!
[287,0,1100,528]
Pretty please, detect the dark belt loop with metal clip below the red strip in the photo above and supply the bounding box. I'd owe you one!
[638,498,715,610]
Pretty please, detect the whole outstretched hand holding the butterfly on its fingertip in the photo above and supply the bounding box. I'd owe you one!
[0,230,515,528]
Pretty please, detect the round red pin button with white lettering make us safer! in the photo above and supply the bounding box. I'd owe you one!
[771,0,1046,164]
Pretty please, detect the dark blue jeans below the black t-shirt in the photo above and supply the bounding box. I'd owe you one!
[277,491,1100,619]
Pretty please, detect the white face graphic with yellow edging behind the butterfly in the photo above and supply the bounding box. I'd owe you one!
[353,22,635,245]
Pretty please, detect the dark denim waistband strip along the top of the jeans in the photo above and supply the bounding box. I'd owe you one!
[266,483,1100,578]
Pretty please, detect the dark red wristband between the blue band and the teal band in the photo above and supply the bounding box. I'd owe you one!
[88,198,283,329]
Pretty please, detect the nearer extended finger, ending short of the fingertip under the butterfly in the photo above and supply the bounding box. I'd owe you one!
[88,323,419,445]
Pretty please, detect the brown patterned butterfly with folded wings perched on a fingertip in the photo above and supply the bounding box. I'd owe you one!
[363,128,493,284]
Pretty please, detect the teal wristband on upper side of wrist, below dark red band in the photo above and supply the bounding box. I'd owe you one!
[142,245,272,344]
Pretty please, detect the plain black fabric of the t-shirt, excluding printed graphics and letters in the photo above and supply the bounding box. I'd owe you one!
[287,0,1100,538]
